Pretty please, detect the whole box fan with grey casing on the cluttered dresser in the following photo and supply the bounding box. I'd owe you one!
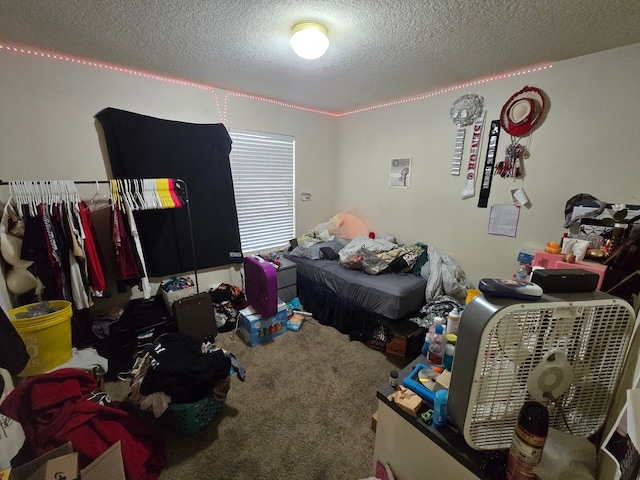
[447,292,635,450]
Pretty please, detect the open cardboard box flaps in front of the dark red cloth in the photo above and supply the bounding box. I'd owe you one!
[8,442,126,480]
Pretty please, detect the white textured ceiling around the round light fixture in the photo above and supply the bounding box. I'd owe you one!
[0,0,640,112]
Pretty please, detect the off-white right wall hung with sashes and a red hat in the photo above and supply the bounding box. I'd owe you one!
[334,44,640,283]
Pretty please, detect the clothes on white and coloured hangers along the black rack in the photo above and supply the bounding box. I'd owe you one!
[0,178,197,309]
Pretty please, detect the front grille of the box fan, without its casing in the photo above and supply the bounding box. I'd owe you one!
[467,300,635,449]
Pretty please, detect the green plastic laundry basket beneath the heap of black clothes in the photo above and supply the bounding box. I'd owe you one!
[160,397,224,435]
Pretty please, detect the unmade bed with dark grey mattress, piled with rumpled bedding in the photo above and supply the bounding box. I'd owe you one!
[285,212,469,341]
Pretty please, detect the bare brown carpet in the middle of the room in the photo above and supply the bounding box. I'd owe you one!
[105,319,407,480]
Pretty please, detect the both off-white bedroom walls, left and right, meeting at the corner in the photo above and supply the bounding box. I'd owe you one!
[0,44,640,310]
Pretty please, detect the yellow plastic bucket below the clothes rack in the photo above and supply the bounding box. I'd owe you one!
[9,300,73,377]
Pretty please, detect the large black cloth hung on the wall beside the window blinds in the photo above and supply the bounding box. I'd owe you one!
[96,108,242,277]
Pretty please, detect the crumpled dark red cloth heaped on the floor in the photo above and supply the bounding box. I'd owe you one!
[0,368,166,480]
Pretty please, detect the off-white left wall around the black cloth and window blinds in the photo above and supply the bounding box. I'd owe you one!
[0,50,335,305]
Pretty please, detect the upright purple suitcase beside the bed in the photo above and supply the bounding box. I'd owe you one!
[244,257,278,318]
